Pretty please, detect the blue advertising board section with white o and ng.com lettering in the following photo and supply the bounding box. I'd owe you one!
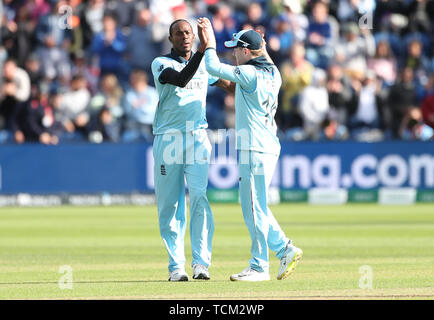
[205,141,434,190]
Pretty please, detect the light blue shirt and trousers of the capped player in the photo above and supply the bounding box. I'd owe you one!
[205,48,289,272]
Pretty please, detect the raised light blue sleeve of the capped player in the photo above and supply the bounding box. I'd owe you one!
[205,48,256,90]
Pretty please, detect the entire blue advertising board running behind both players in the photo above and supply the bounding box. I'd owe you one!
[0,142,434,194]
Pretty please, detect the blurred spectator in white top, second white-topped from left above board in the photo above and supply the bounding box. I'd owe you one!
[59,75,90,140]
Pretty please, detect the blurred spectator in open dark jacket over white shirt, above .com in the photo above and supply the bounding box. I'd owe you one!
[348,70,385,141]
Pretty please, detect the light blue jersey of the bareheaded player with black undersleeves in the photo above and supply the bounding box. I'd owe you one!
[151,50,219,135]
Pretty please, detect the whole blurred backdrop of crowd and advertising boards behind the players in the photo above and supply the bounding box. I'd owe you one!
[0,0,434,205]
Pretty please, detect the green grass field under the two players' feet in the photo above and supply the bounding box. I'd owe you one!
[0,204,434,300]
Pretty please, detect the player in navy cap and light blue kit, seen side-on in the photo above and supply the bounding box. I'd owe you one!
[198,18,303,281]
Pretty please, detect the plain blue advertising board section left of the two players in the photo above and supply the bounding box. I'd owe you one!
[0,144,150,194]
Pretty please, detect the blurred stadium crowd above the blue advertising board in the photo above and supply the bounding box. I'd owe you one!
[0,0,434,144]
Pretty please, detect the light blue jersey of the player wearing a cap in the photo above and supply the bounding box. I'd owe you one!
[205,49,282,155]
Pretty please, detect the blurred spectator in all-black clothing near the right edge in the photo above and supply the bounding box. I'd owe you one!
[388,67,417,138]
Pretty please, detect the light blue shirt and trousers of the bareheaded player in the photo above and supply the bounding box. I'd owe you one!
[151,51,218,272]
